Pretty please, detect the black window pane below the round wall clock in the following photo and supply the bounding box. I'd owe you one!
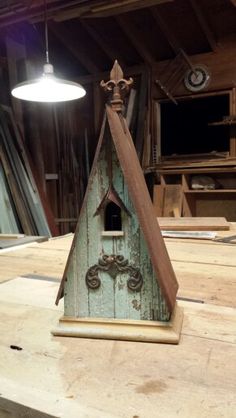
[161,93,230,157]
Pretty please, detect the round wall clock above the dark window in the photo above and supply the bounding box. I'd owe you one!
[184,65,210,92]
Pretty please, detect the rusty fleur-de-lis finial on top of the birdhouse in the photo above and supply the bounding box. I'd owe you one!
[100,60,133,112]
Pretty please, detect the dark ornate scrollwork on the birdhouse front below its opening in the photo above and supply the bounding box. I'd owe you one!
[85,254,143,292]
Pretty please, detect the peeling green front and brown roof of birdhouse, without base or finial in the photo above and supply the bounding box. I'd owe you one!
[56,107,178,321]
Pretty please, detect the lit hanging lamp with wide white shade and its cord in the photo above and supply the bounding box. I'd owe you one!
[11,0,86,102]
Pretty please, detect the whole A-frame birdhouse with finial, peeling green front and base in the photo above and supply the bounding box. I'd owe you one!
[53,62,182,343]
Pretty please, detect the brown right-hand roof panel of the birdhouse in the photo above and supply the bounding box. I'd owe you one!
[106,106,178,312]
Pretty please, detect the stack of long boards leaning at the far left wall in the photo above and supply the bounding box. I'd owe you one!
[0,106,51,236]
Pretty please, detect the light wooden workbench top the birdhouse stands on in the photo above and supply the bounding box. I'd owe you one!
[0,230,236,418]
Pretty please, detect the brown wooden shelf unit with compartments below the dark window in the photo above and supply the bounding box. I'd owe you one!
[154,167,236,222]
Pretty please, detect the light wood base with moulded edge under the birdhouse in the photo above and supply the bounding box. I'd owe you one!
[52,305,183,344]
